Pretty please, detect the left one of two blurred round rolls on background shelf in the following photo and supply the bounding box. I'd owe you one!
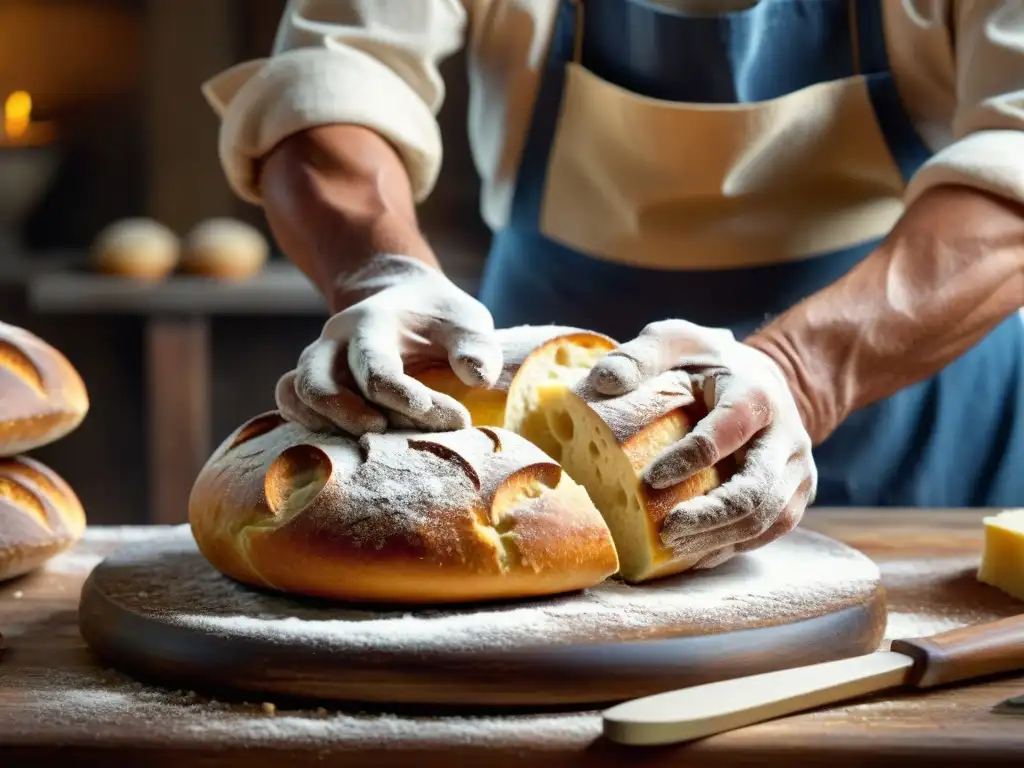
[90,218,180,283]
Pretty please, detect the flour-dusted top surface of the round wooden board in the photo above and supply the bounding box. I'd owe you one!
[90,526,879,653]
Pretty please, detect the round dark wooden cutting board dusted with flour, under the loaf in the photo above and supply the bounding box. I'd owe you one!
[80,525,886,707]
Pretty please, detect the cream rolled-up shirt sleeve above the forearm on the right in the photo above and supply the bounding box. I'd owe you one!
[904,0,1024,203]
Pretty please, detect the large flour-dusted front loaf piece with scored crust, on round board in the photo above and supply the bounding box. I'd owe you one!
[188,412,617,604]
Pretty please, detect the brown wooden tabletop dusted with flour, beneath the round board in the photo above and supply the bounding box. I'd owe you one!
[0,510,1024,768]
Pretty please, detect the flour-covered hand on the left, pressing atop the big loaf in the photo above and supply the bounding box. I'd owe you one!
[276,255,502,436]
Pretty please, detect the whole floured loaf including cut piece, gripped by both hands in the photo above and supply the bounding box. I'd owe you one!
[189,327,727,603]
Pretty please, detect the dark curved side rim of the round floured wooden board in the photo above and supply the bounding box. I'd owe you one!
[79,575,887,707]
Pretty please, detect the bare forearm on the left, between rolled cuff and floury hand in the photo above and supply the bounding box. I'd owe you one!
[260,125,438,311]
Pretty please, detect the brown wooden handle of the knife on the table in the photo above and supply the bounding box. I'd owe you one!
[891,615,1024,688]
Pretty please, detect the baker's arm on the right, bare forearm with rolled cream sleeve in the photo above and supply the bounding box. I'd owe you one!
[746,0,1024,442]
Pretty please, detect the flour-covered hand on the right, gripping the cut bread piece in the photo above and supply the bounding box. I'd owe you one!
[591,321,817,568]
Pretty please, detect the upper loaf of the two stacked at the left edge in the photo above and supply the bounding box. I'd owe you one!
[0,323,89,457]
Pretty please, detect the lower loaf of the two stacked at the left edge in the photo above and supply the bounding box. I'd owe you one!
[0,457,85,581]
